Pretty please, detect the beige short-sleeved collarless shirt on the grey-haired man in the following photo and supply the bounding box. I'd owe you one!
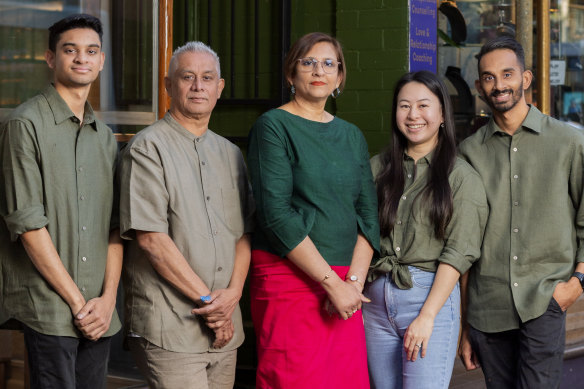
[120,113,253,353]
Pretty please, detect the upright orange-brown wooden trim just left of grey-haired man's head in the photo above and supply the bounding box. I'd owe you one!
[158,0,173,119]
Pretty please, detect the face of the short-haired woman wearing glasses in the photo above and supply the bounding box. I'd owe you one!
[288,42,341,101]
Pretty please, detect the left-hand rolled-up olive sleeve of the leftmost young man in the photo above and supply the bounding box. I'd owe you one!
[0,120,49,241]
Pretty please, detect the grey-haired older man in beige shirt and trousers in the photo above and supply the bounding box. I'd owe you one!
[120,42,253,388]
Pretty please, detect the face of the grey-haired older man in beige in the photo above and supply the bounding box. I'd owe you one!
[165,51,225,121]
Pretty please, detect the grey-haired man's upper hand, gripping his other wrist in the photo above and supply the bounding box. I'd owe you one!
[191,288,241,330]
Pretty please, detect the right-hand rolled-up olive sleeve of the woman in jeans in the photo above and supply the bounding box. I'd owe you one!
[438,167,489,274]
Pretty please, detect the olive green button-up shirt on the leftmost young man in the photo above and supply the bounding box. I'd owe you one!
[0,85,120,337]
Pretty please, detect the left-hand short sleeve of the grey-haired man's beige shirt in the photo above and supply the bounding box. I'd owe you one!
[118,144,169,239]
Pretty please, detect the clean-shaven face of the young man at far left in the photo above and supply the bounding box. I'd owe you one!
[45,28,105,88]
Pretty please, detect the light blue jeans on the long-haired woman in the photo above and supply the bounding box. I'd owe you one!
[363,266,460,389]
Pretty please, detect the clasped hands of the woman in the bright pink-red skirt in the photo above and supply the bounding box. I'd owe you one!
[322,273,371,320]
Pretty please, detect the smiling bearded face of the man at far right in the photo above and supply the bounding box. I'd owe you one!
[475,49,531,114]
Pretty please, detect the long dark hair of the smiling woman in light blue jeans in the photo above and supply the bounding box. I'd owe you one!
[376,71,456,239]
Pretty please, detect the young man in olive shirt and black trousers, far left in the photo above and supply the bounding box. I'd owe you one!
[0,15,122,389]
